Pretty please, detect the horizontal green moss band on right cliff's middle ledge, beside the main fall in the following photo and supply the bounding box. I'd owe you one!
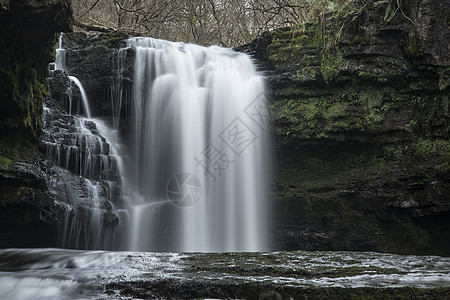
[271,85,411,142]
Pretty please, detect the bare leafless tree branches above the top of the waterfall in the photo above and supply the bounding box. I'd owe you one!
[73,0,338,47]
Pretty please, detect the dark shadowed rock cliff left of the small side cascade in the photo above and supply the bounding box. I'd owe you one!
[0,0,72,247]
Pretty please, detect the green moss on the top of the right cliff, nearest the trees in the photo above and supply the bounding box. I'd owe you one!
[267,1,406,84]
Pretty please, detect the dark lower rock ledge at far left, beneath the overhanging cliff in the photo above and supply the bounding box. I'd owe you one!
[0,162,65,248]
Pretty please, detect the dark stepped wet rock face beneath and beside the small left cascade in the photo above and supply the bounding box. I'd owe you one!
[40,33,132,249]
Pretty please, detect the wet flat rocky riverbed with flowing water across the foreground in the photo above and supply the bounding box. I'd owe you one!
[0,249,450,300]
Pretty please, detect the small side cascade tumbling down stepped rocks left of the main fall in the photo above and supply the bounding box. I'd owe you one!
[41,34,123,249]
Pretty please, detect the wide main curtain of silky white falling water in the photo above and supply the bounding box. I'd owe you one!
[125,38,270,252]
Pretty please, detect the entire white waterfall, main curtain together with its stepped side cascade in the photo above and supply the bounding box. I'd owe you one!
[43,35,271,252]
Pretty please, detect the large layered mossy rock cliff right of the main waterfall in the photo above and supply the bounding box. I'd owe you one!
[240,0,450,255]
